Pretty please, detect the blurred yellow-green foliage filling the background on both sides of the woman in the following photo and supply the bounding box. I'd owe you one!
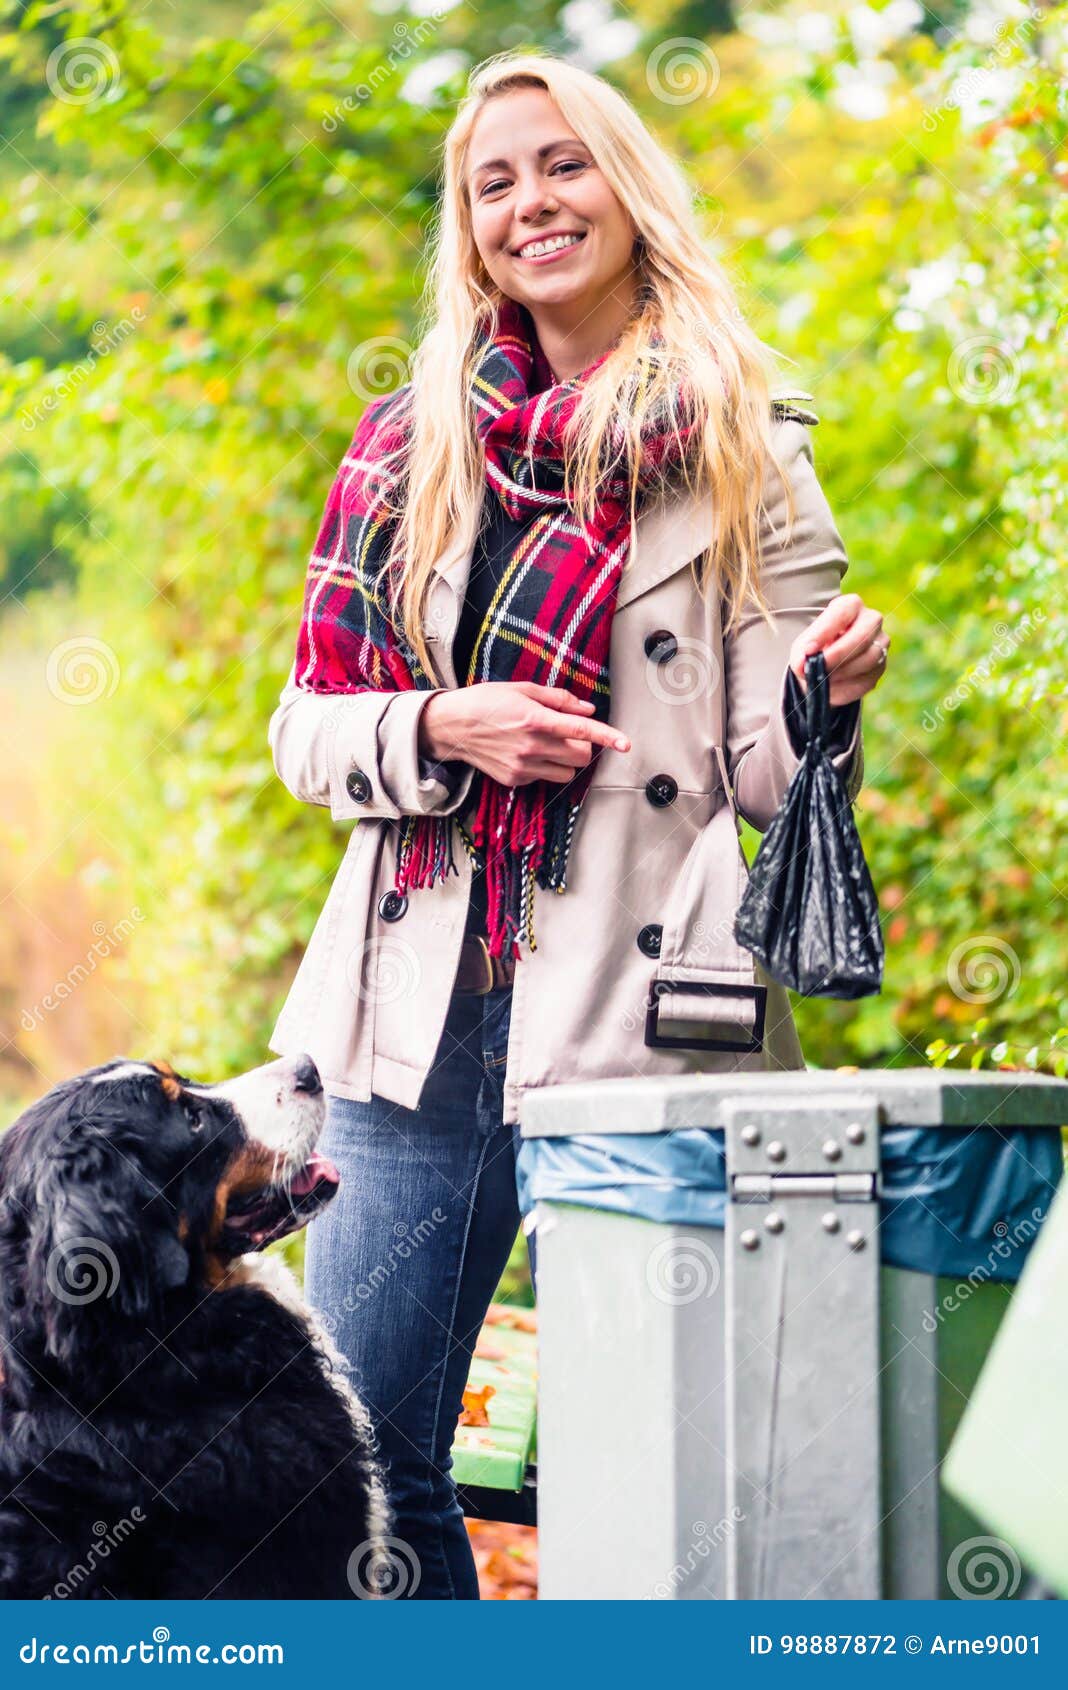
[0,0,1068,1095]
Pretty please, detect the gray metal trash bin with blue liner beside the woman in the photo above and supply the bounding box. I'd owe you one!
[520,1068,1068,1599]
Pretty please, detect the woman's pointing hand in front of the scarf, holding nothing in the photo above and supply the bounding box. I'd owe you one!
[419,681,630,786]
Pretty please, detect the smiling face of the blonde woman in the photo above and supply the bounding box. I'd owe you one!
[465,88,637,324]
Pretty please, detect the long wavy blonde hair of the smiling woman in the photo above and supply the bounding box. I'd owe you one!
[370,52,794,674]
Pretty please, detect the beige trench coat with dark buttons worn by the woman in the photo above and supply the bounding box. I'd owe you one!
[269,417,864,1122]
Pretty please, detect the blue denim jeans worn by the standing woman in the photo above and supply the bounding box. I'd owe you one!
[304,987,520,1600]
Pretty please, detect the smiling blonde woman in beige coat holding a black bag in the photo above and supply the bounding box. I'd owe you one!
[270,54,889,1599]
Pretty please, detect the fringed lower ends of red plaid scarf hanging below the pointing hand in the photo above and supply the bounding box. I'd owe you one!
[394,779,581,958]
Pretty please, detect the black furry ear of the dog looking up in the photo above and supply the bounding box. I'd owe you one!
[25,1120,189,1369]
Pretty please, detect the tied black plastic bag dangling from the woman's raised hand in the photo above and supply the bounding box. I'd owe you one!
[733,651,884,997]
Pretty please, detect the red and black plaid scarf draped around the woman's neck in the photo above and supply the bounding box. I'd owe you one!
[296,301,689,957]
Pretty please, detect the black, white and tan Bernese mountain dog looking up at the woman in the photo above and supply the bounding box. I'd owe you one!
[0,1056,389,1599]
